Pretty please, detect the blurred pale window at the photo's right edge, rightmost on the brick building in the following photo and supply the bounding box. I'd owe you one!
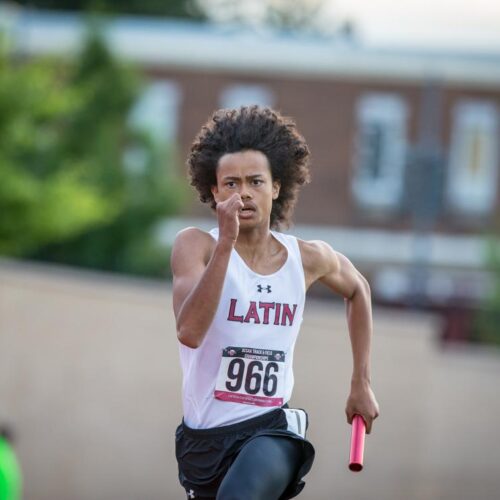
[446,101,499,215]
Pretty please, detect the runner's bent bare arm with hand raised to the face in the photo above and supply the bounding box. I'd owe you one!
[171,195,243,349]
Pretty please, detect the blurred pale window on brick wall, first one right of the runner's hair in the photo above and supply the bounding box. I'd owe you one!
[352,94,408,209]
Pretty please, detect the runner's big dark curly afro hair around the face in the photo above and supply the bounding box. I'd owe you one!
[187,106,310,228]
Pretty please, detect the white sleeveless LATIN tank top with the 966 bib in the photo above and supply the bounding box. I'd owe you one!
[179,229,305,429]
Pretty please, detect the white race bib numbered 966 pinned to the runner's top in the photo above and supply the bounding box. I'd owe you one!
[214,347,285,406]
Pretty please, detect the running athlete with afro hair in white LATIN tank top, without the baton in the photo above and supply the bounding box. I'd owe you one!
[172,106,378,500]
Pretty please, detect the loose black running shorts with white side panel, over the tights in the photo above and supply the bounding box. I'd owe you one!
[175,408,314,500]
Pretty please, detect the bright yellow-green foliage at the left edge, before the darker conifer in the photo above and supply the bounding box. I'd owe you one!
[0,37,118,256]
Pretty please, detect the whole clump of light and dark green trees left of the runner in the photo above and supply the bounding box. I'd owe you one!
[0,29,183,275]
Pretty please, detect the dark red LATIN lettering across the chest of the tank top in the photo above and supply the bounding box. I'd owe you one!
[227,299,297,326]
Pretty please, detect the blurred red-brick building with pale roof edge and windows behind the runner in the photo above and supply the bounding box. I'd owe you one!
[6,6,500,302]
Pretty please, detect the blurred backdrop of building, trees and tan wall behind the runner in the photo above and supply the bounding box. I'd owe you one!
[0,0,500,500]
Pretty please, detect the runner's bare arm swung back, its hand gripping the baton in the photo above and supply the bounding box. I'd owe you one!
[301,241,379,434]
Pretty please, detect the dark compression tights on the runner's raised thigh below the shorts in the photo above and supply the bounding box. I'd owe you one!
[216,436,302,500]
